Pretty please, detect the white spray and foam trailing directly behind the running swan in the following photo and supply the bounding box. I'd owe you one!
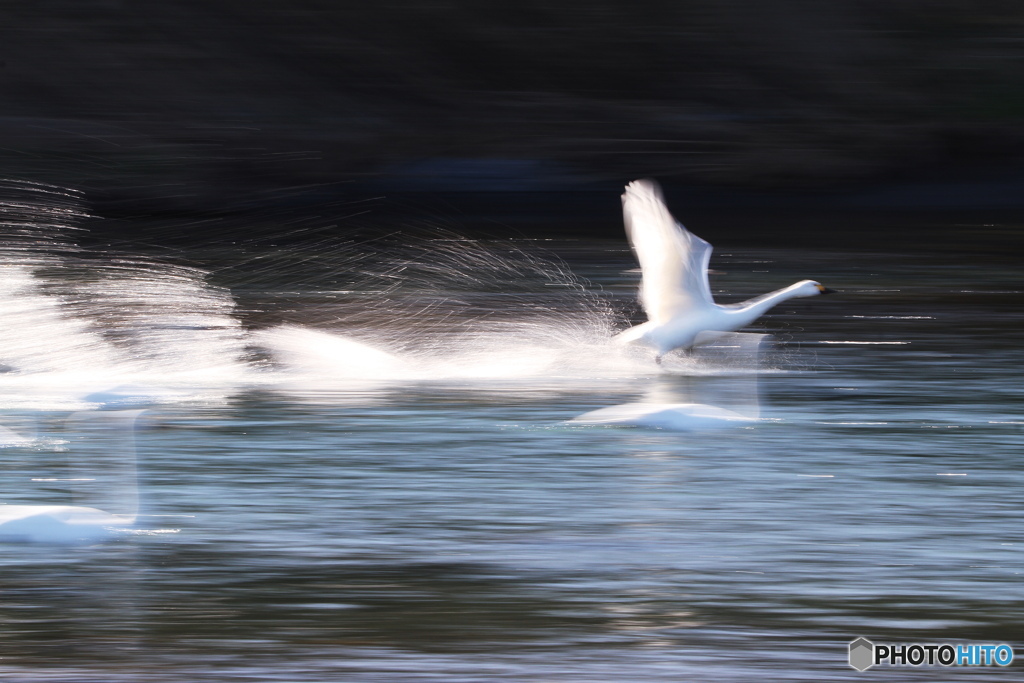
[243,234,778,390]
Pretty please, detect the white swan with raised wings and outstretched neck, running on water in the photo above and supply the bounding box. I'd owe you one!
[615,180,833,364]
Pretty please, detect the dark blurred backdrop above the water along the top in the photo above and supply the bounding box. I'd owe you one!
[0,0,1024,232]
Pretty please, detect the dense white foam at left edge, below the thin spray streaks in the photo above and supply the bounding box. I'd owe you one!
[0,262,252,409]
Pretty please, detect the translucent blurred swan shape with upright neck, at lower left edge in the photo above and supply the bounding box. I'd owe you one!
[0,411,141,543]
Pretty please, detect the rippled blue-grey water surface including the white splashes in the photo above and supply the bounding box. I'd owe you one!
[0,184,1024,683]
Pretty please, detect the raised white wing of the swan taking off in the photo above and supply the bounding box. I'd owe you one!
[623,180,713,324]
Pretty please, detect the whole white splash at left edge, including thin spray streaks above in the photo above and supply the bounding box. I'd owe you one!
[0,181,249,409]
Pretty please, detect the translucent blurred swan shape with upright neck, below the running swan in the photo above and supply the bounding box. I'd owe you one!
[569,333,766,431]
